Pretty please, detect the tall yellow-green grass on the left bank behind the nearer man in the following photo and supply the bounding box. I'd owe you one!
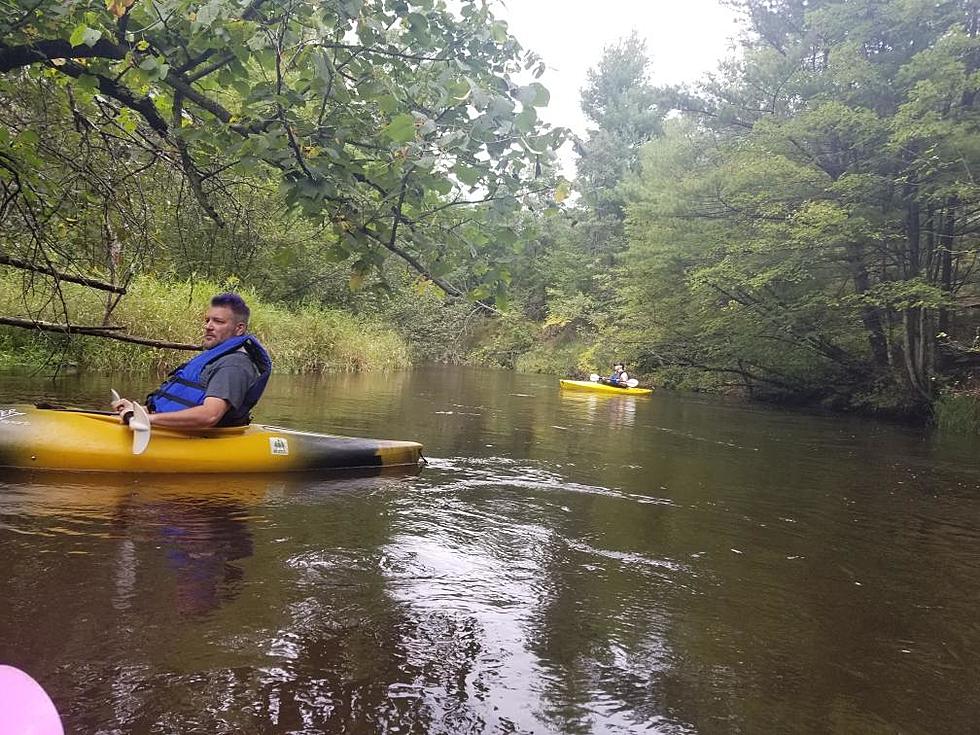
[0,274,411,373]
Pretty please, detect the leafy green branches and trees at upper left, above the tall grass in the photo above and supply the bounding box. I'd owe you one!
[0,0,563,342]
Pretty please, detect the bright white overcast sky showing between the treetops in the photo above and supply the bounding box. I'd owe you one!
[492,0,739,175]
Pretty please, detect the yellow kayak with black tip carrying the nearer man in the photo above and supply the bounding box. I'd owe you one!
[0,405,422,473]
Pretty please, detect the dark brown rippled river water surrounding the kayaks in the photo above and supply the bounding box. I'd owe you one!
[0,369,980,734]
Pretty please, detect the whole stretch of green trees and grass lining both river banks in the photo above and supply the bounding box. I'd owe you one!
[0,0,980,430]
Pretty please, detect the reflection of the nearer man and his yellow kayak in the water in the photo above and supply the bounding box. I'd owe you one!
[0,472,272,616]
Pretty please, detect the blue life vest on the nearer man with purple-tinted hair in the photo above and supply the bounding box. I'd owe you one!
[146,334,272,426]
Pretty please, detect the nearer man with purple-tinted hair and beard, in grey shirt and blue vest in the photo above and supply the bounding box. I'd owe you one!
[112,293,272,429]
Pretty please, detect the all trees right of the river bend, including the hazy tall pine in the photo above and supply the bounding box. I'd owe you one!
[472,0,980,426]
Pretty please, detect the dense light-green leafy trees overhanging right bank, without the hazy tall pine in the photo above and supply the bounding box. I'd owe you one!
[627,0,980,412]
